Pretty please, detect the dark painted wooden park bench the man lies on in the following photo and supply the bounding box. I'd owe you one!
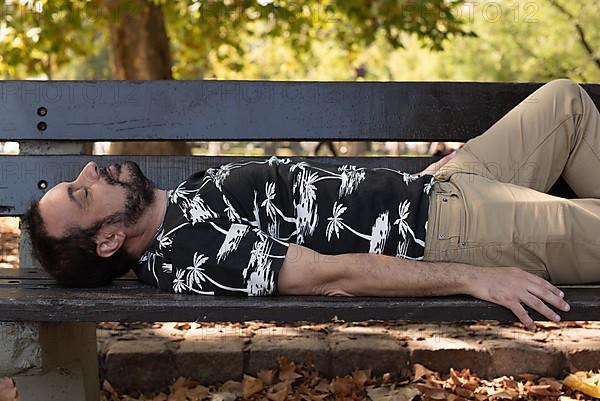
[0,81,600,401]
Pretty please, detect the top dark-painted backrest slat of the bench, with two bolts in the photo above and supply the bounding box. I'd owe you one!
[0,80,600,141]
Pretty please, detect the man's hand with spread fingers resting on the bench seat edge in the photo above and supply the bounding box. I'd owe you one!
[470,267,570,330]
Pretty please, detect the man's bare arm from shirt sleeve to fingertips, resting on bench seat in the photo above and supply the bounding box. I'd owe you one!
[278,244,569,329]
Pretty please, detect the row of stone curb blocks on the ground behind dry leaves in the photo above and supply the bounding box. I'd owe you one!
[99,324,600,392]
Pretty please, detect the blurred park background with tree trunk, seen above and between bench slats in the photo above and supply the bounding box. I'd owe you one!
[0,0,600,267]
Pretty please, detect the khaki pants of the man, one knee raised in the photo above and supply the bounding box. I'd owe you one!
[424,79,600,284]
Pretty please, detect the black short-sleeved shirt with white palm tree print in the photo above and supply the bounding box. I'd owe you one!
[134,156,435,296]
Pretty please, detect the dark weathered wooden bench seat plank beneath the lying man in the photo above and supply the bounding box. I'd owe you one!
[0,269,600,322]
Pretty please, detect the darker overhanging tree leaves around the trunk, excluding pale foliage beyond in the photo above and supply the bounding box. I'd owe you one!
[0,0,465,78]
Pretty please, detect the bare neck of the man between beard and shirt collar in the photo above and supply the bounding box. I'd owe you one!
[125,189,168,259]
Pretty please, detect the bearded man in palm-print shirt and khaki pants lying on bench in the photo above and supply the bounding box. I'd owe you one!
[25,79,600,328]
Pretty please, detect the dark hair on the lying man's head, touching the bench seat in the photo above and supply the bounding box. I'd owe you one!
[22,200,137,287]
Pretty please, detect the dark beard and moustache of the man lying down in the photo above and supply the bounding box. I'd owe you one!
[99,161,156,226]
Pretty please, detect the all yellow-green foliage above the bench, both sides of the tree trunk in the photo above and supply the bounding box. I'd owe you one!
[0,0,600,82]
